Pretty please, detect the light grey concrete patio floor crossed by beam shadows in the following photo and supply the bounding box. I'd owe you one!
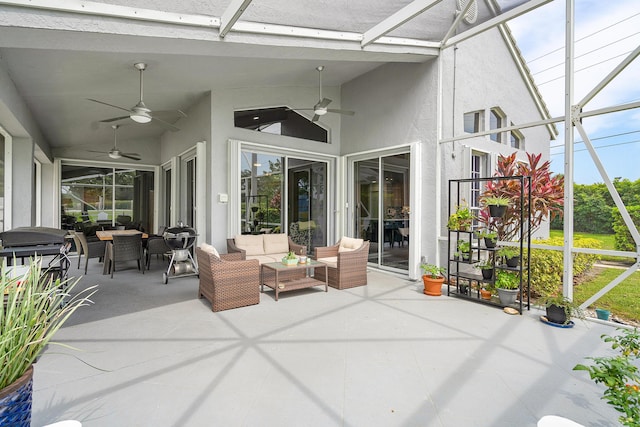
[32,259,618,427]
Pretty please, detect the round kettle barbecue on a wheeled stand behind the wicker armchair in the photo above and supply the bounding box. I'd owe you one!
[162,223,198,285]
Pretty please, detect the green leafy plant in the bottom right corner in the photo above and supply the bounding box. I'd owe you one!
[573,329,640,427]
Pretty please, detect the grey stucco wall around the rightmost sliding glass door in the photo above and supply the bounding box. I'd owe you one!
[341,61,438,270]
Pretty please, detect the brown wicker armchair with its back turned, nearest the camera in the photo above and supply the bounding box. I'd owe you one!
[196,247,260,311]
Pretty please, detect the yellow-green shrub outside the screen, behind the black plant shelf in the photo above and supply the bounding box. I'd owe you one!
[529,238,601,296]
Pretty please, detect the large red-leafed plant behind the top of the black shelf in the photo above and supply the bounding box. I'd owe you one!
[478,152,564,241]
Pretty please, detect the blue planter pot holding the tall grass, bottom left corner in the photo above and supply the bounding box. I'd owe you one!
[0,366,33,427]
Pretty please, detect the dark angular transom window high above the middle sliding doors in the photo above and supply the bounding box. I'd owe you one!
[233,107,329,143]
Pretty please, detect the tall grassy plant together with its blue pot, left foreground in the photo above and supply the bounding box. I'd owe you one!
[0,260,95,427]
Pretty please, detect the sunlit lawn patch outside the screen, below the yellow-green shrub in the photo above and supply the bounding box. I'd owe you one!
[573,268,640,322]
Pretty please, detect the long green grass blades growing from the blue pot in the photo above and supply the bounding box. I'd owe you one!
[0,260,95,389]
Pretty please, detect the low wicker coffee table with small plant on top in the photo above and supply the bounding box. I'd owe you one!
[260,260,329,301]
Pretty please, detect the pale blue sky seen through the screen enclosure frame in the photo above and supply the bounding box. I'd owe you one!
[509,0,640,184]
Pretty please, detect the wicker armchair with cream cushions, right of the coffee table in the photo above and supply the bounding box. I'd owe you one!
[314,238,369,289]
